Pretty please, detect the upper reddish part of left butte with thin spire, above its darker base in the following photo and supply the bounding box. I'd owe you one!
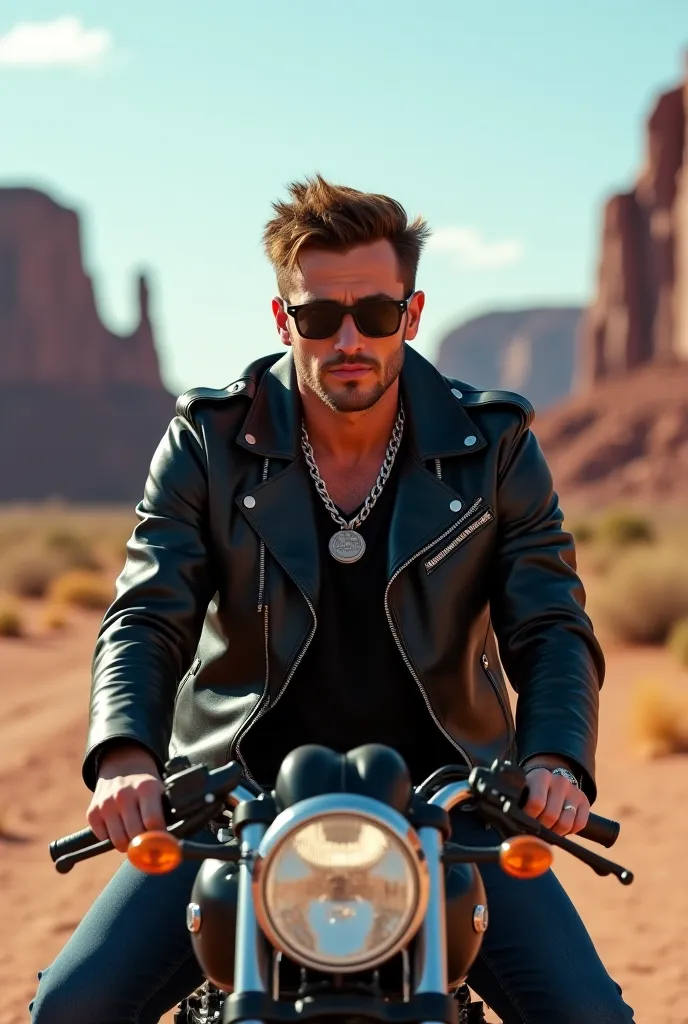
[0,188,162,391]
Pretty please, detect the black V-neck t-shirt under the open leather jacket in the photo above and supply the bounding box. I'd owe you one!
[242,443,458,785]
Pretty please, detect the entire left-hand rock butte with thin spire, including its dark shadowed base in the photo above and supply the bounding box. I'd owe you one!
[0,188,174,504]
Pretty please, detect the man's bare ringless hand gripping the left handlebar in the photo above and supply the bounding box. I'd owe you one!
[86,743,166,853]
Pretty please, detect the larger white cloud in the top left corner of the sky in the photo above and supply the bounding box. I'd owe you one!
[0,16,113,68]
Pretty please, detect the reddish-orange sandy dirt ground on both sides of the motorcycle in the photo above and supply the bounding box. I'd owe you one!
[0,614,688,1024]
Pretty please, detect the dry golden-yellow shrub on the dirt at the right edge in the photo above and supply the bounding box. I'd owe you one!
[631,679,688,758]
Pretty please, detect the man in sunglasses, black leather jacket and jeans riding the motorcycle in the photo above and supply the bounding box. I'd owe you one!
[33,176,633,1024]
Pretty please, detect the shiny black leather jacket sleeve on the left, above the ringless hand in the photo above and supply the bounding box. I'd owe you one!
[83,416,216,790]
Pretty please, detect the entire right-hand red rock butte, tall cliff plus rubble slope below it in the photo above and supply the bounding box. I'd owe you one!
[534,60,688,507]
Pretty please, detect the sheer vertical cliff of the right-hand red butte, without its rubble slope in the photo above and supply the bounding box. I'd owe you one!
[579,61,688,390]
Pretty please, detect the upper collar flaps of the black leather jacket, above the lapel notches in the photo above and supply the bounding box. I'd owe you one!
[237,344,486,462]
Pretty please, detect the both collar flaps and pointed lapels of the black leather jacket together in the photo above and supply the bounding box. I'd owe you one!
[237,346,486,607]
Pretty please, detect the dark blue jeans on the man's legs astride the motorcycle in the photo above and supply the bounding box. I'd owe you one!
[30,812,633,1024]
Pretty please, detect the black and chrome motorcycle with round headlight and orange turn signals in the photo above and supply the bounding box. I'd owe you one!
[50,744,633,1024]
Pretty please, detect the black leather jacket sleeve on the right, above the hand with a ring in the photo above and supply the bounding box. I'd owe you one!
[490,421,604,801]
